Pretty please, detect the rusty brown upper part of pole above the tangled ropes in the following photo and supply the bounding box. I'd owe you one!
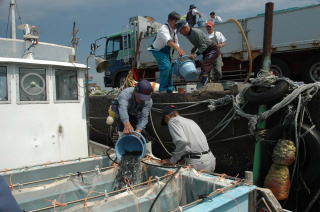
[262,2,274,73]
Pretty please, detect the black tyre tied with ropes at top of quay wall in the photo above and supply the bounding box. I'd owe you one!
[244,80,289,104]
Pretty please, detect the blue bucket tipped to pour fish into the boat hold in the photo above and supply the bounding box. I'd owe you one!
[115,132,146,160]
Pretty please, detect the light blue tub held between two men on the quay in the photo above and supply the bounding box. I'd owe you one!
[172,56,199,81]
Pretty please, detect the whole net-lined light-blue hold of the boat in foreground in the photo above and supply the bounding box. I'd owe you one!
[13,159,231,212]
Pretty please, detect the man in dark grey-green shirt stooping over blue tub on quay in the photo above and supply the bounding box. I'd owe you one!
[177,20,220,85]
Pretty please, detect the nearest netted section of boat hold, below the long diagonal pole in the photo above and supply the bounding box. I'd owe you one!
[57,169,222,212]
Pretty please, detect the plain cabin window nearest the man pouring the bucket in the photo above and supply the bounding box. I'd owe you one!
[55,70,78,100]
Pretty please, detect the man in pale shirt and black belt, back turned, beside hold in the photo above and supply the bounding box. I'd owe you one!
[161,105,216,172]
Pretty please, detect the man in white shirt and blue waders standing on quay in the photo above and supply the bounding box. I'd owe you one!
[149,12,185,93]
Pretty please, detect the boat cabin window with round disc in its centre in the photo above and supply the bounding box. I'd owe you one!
[19,68,47,101]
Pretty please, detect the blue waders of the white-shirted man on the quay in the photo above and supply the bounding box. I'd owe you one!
[152,46,174,93]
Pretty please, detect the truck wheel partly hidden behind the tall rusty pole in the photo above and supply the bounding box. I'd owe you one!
[253,57,291,78]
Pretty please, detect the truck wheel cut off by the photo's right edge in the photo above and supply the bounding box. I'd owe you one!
[303,56,320,82]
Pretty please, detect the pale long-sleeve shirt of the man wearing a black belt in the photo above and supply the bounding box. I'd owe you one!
[168,116,209,163]
